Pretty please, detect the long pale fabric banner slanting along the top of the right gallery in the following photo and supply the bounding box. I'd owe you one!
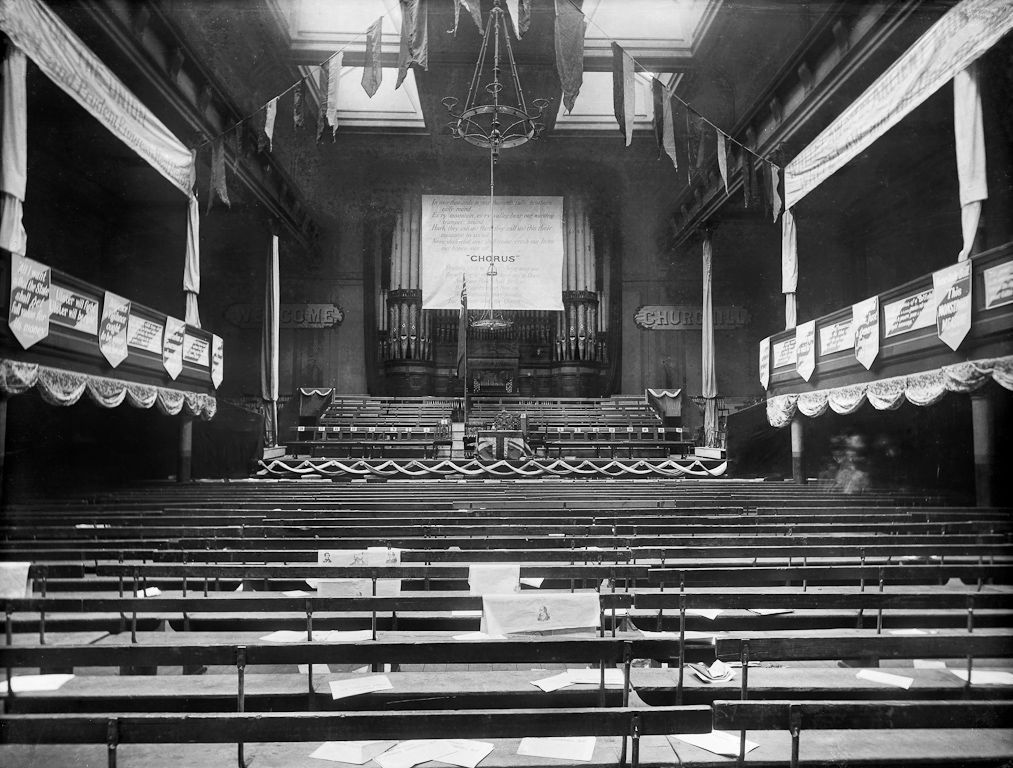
[784,0,1013,209]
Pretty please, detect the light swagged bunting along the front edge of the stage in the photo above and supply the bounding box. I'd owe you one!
[254,456,728,479]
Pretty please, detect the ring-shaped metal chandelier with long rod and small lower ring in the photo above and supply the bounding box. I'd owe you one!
[443,0,549,330]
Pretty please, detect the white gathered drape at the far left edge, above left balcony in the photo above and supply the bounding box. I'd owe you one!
[0,42,28,256]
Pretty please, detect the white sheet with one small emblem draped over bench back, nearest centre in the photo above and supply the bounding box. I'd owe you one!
[480,592,601,634]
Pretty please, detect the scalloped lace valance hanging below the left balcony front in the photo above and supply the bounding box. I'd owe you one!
[0,360,218,419]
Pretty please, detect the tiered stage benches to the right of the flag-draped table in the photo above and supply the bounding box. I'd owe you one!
[468,396,693,458]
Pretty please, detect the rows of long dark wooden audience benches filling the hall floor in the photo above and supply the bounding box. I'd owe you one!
[0,480,1013,767]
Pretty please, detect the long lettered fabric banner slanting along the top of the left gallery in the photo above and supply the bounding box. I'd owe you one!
[0,0,192,193]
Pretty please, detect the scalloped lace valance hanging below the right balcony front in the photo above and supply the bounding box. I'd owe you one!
[767,356,1013,427]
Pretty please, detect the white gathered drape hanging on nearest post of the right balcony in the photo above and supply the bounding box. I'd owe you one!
[953,62,989,261]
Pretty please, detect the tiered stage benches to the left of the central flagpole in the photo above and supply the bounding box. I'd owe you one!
[289,395,454,458]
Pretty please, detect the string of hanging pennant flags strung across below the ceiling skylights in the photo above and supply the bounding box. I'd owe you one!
[196,0,782,221]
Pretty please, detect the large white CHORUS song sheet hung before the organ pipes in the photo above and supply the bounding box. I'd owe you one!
[421,195,563,310]
